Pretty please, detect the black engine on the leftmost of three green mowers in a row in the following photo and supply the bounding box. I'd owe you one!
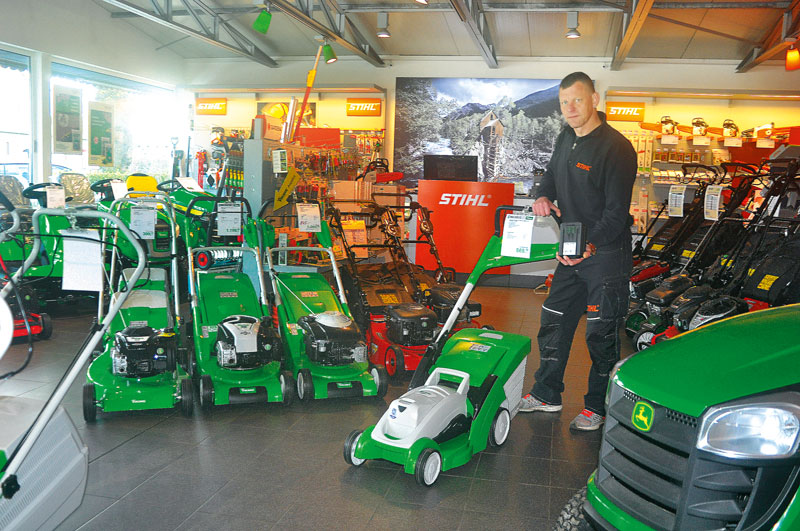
[111,325,176,378]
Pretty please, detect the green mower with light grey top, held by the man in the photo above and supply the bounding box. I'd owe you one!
[344,206,558,487]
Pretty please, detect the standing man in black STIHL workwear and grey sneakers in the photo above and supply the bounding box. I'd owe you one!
[520,72,636,430]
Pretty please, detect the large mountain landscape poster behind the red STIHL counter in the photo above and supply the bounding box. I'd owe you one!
[394,77,564,191]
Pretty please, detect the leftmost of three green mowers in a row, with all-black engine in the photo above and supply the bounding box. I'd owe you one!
[83,197,193,422]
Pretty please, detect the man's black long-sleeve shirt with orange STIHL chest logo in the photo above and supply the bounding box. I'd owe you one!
[536,113,637,248]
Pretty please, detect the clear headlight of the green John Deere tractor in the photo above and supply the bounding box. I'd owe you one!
[697,403,800,458]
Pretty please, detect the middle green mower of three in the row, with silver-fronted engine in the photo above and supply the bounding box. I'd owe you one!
[188,219,294,411]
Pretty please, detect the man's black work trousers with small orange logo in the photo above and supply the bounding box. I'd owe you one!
[531,240,632,416]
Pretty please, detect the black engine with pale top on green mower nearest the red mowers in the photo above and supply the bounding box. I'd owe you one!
[297,311,367,366]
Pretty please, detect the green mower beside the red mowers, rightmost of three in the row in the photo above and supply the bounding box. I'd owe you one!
[267,216,389,402]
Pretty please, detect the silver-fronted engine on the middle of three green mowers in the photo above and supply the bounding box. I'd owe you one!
[214,315,281,369]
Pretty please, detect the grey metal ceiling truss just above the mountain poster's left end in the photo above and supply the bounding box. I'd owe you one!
[269,0,386,66]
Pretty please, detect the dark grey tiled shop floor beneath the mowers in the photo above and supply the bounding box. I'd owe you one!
[0,287,630,531]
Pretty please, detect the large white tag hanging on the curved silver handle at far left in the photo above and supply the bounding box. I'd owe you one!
[61,230,104,291]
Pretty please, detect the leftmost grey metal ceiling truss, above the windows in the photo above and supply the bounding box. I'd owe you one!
[103,0,278,68]
